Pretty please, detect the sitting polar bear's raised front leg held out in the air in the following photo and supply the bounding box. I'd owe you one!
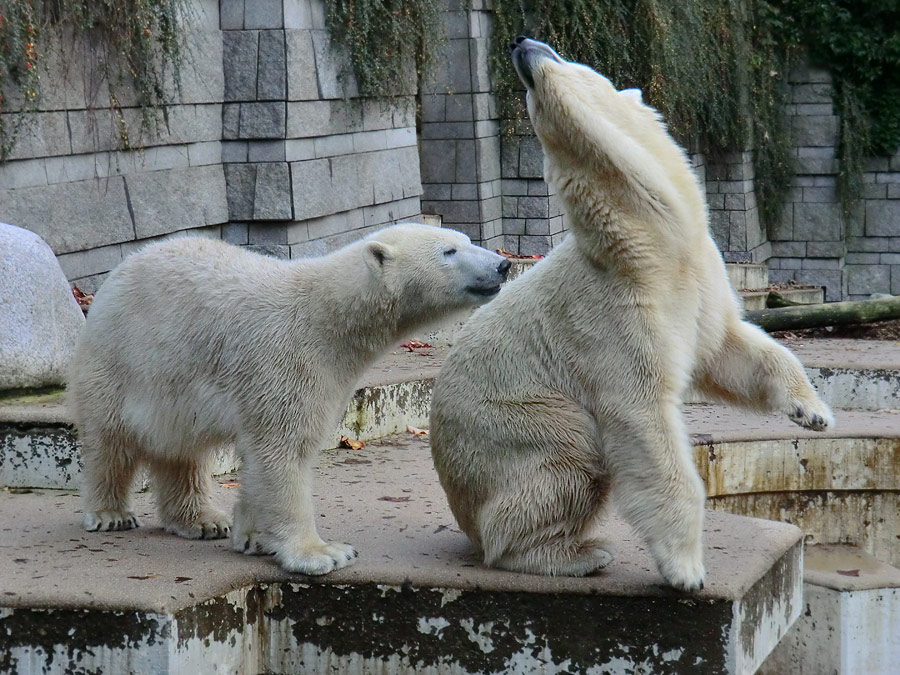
[694,321,834,431]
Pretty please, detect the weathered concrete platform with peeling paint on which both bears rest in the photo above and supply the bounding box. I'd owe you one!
[0,434,802,675]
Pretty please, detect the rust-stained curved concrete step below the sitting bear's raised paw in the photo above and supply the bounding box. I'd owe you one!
[685,405,900,565]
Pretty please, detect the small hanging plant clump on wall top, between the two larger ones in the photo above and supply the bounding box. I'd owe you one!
[325,0,444,96]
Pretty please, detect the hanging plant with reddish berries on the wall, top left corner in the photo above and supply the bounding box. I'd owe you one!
[0,0,191,159]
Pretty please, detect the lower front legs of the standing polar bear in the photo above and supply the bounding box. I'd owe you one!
[231,444,358,575]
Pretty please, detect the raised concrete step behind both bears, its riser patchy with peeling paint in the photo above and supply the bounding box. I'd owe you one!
[0,340,900,489]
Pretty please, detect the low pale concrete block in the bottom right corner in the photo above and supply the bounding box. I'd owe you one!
[759,546,900,675]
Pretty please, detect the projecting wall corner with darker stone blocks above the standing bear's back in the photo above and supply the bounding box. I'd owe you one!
[222,0,421,257]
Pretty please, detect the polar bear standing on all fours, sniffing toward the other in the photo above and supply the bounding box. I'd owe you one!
[69,224,509,574]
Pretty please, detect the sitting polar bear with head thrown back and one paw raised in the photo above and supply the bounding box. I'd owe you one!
[431,38,833,591]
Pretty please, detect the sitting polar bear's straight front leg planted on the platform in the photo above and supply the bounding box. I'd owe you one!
[602,403,706,591]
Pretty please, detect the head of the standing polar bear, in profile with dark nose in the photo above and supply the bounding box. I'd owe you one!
[363,223,510,316]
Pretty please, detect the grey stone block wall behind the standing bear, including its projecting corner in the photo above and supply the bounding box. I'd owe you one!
[0,0,421,291]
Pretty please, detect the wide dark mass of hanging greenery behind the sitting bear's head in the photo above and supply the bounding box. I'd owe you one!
[492,0,900,232]
